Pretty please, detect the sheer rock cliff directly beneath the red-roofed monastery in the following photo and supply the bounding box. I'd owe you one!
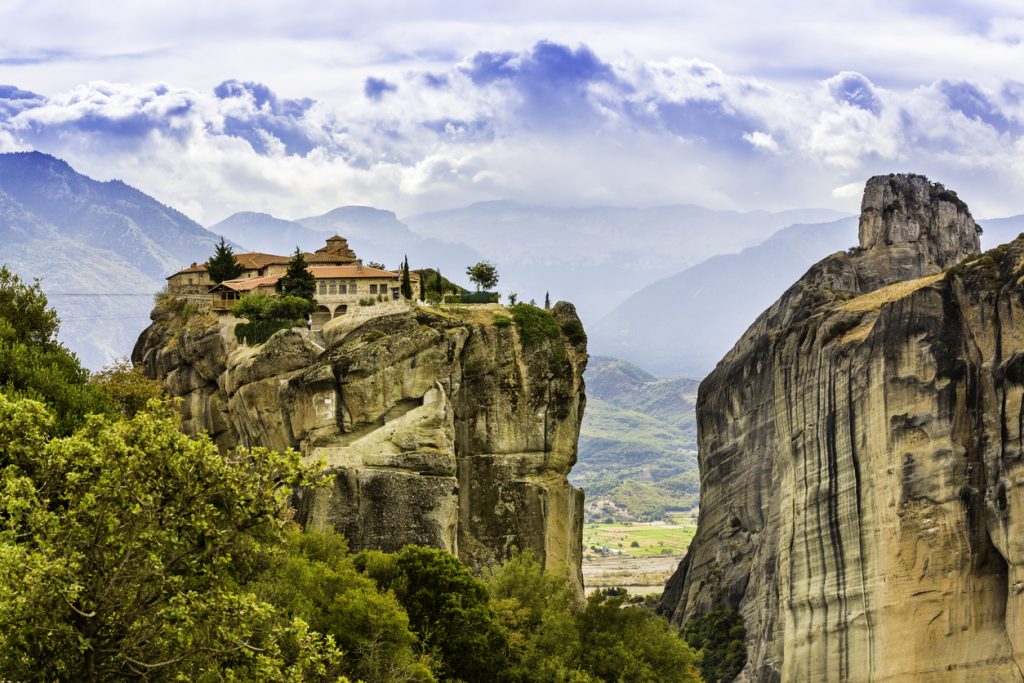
[133,303,587,589]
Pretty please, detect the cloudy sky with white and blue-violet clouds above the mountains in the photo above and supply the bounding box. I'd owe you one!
[0,0,1024,224]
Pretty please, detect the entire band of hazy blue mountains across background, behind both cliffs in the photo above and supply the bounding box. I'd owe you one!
[0,148,1024,378]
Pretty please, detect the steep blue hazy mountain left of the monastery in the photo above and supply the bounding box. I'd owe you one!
[0,153,215,369]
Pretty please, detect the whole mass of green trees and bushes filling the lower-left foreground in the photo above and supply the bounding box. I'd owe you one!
[0,280,696,683]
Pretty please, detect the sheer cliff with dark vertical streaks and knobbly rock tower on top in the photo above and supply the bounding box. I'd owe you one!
[662,176,1024,681]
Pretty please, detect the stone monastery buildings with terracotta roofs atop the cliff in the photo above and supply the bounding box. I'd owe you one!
[167,234,420,329]
